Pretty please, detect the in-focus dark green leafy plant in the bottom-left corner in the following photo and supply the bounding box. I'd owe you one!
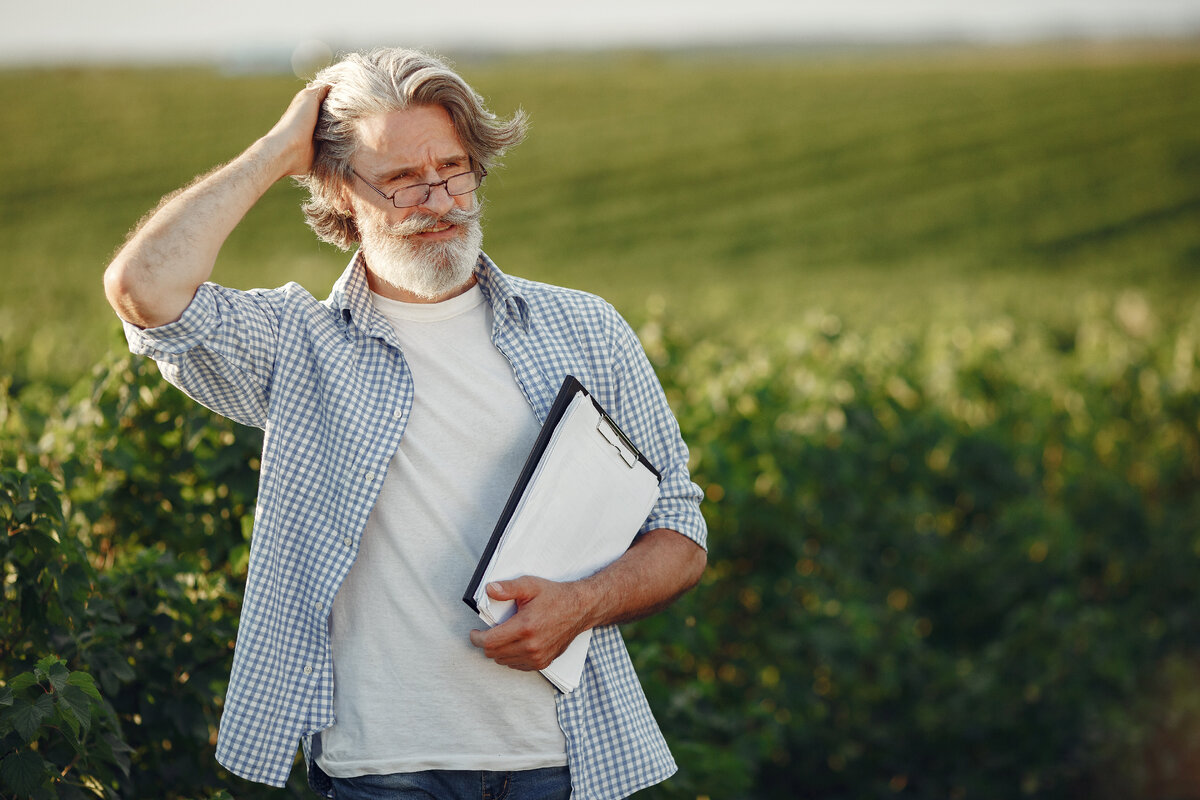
[0,469,130,800]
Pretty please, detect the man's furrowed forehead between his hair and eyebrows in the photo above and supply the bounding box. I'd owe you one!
[354,106,466,170]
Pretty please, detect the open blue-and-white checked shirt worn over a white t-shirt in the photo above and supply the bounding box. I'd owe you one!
[119,253,707,799]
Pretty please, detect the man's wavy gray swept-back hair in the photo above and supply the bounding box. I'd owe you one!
[296,48,527,249]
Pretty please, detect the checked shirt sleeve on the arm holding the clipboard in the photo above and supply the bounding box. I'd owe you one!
[612,309,708,549]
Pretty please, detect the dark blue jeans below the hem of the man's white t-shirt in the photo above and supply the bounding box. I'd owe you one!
[332,766,571,800]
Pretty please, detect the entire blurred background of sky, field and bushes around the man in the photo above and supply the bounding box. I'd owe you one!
[0,0,1200,798]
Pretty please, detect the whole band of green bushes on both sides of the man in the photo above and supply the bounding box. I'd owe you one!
[0,294,1200,799]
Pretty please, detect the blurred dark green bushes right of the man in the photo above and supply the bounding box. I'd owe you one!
[631,295,1200,798]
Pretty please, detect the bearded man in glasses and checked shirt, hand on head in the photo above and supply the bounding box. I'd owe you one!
[104,49,707,800]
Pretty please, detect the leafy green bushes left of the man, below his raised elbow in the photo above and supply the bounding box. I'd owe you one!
[0,364,304,799]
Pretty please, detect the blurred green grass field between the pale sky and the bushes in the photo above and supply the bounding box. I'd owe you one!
[0,42,1200,380]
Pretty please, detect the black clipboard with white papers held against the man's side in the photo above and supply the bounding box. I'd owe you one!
[462,375,662,692]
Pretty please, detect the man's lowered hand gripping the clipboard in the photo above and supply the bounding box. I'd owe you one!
[470,576,592,670]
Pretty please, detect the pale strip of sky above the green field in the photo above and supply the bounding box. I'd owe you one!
[9,0,1200,66]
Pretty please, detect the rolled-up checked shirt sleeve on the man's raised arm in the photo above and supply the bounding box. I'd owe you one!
[125,283,278,428]
